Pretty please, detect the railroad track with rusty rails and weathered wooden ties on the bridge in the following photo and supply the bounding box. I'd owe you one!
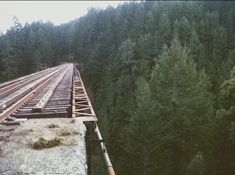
[0,64,73,124]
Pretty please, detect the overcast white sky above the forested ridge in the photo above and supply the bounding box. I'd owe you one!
[0,1,123,33]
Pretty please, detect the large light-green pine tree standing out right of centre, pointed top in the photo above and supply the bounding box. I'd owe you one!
[151,39,212,175]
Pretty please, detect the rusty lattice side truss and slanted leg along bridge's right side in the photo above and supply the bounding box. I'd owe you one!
[71,67,115,175]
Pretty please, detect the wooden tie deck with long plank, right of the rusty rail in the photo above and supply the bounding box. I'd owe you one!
[11,64,73,118]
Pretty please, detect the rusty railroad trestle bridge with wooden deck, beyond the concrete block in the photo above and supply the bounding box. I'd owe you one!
[0,63,115,175]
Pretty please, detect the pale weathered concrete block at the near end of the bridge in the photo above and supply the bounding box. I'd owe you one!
[0,118,87,175]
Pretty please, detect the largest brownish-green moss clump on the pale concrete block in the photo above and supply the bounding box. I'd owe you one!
[33,137,61,149]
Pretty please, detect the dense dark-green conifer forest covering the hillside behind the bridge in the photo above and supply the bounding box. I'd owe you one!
[0,1,235,175]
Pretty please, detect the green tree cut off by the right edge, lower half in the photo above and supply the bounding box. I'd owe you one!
[211,67,235,175]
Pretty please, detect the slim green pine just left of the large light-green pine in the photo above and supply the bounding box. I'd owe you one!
[122,77,159,175]
